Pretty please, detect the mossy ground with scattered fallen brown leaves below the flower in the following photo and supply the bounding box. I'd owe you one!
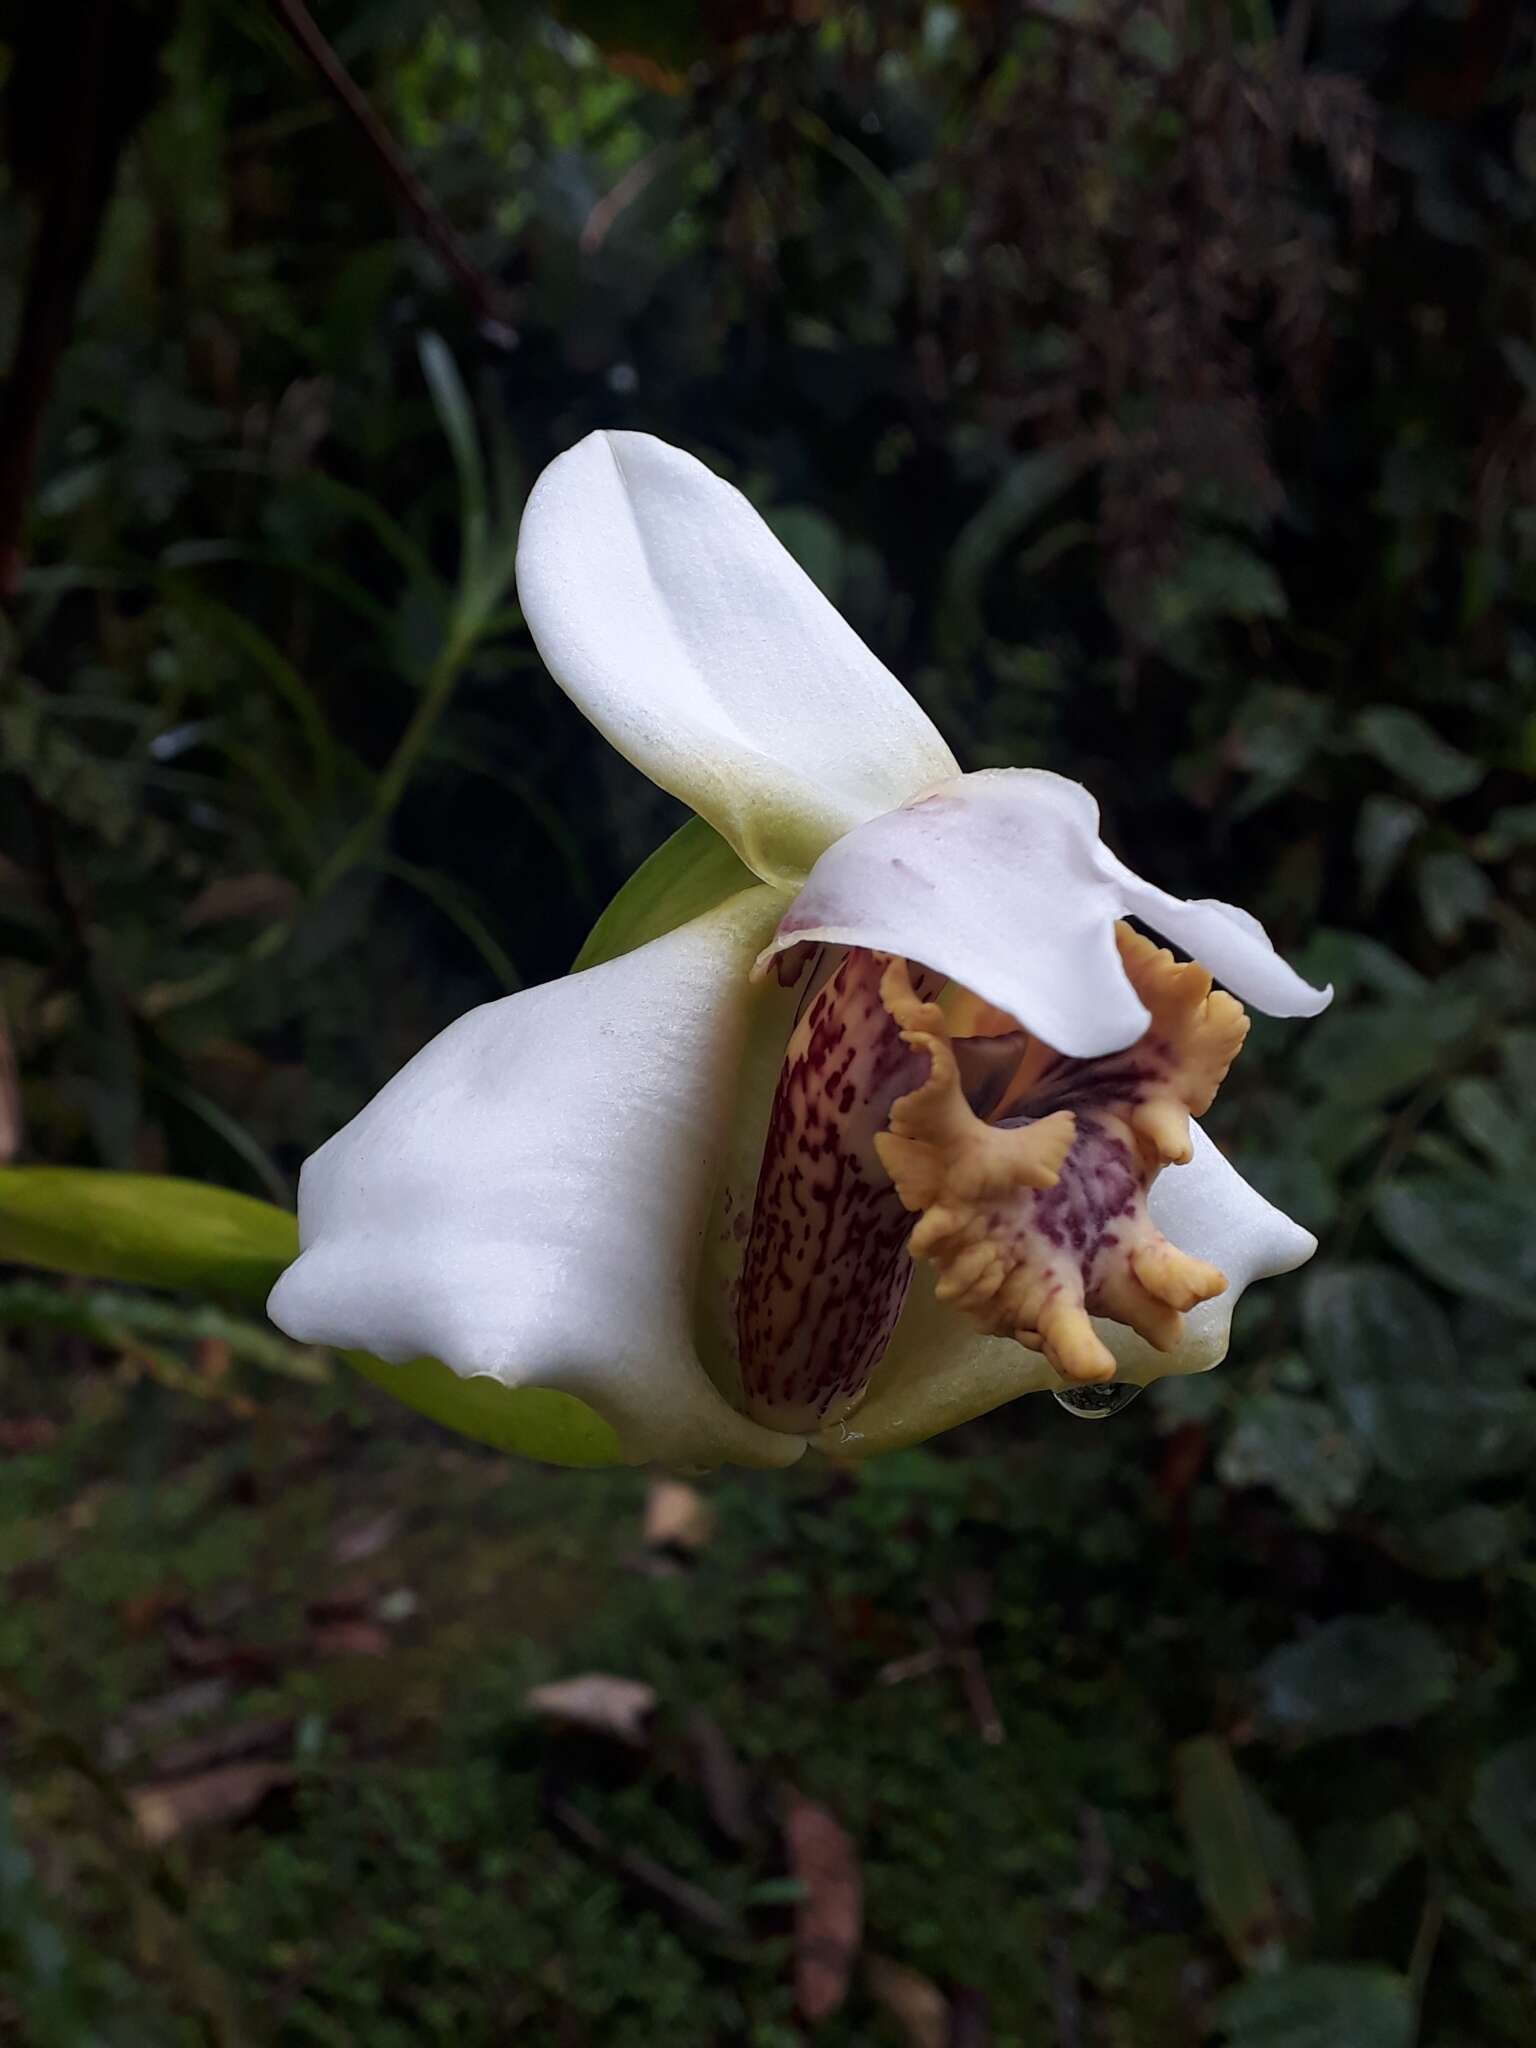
[0,1374,1518,2048]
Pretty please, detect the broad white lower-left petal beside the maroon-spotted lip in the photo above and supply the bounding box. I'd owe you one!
[268,889,805,1464]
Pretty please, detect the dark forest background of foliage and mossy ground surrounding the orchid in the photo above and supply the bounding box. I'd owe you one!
[0,0,1536,2048]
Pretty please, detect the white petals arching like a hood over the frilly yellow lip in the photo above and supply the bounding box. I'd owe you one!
[764,768,1329,1059]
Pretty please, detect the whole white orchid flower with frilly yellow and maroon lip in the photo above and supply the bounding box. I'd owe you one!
[270,434,1329,1466]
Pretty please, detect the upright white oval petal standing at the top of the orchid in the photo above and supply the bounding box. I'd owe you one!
[518,432,956,887]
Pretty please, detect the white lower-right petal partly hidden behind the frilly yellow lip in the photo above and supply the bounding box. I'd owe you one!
[811,1124,1317,1458]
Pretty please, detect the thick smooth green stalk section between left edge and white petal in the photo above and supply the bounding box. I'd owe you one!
[0,1165,299,1300]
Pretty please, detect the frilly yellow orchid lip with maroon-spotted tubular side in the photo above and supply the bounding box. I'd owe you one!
[737,926,1247,1430]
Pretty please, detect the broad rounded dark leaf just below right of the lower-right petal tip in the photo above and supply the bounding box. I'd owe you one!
[1303,1266,1532,1481]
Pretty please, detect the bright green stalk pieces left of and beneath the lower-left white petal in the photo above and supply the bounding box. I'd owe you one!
[0,1165,623,1464]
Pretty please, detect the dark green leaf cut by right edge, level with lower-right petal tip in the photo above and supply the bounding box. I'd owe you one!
[1374,1174,1536,1321]
